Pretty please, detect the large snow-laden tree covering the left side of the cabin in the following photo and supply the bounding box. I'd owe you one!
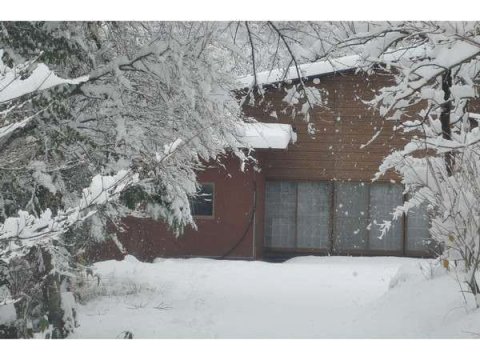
[0,22,342,336]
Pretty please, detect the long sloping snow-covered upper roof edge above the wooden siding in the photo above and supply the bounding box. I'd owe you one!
[237,55,360,87]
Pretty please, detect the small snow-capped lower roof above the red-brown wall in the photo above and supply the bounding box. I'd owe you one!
[237,122,297,149]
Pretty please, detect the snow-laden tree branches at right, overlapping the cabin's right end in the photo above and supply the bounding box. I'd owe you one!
[322,21,480,305]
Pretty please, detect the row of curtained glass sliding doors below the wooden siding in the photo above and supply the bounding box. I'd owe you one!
[265,181,429,254]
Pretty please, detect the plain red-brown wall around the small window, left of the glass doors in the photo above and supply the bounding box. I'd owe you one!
[92,156,264,261]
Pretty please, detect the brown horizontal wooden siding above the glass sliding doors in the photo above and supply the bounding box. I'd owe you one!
[244,72,420,181]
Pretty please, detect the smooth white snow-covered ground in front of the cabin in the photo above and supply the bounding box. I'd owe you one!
[71,256,480,338]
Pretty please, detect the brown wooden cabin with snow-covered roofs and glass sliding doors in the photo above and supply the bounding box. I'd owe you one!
[92,57,432,260]
